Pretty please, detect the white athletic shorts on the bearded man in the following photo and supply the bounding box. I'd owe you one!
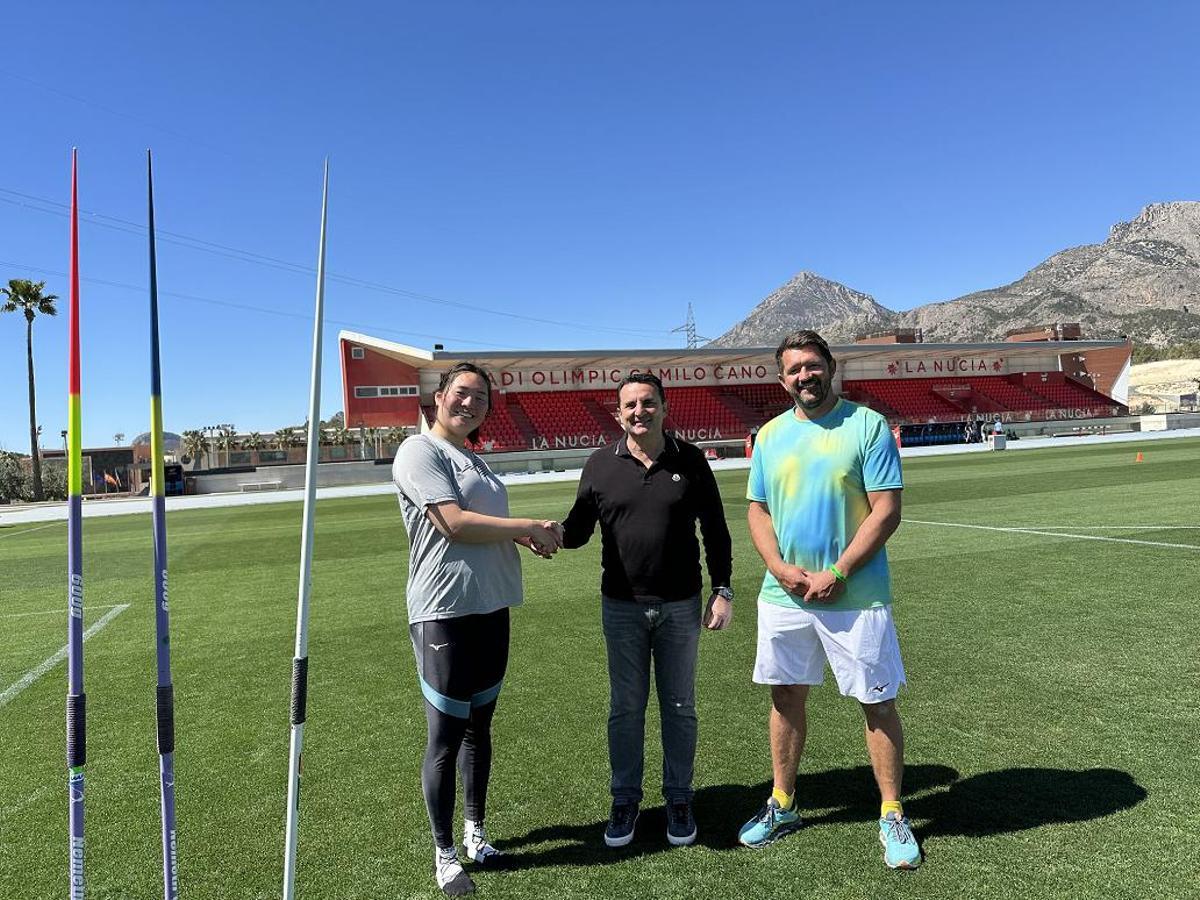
[754,600,905,703]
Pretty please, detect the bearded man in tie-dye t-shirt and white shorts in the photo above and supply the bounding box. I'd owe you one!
[738,331,922,869]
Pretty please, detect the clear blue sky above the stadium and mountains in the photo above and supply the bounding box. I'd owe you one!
[0,0,1200,451]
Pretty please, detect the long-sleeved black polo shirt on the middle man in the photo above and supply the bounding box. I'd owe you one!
[563,434,733,602]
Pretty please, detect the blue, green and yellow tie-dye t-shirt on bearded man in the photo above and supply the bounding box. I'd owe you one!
[746,400,904,610]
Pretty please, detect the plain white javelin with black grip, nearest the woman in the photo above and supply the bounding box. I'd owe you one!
[283,158,329,900]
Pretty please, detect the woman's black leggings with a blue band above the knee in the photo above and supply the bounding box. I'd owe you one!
[409,608,509,847]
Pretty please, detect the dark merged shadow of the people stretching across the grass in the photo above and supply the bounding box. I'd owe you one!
[500,764,1146,869]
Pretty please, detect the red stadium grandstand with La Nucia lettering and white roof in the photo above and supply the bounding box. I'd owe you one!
[338,325,1132,452]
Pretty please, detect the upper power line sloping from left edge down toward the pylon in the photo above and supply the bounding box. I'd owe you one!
[0,187,666,337]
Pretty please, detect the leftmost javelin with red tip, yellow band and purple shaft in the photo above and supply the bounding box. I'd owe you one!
[67,149,88,900]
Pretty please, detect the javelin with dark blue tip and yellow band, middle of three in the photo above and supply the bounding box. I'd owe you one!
[146,150,179,900]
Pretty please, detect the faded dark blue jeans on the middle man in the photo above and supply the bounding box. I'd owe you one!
[601,596,700,803]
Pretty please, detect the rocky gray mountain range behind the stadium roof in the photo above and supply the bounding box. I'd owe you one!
[709,202,1200,347]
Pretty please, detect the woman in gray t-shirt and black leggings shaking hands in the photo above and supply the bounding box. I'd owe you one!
[392,362,562,896]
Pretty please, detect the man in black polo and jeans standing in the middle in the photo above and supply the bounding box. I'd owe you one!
[563,373,733,847]
